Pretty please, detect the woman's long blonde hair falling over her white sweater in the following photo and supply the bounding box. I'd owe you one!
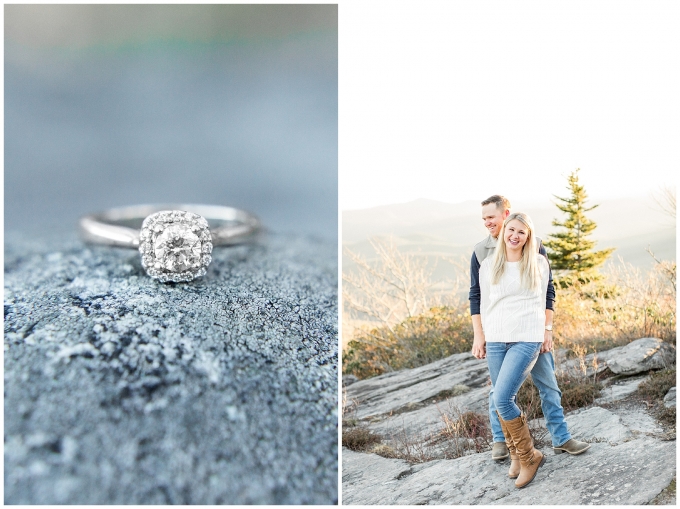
[491,212,541,290]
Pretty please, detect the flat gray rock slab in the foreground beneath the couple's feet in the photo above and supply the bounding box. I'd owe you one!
[342,437,675,506]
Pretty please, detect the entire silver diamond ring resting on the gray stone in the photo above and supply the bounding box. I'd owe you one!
[80,205,260,283]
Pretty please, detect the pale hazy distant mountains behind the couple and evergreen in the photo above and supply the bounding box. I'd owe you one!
[342,197,676,271]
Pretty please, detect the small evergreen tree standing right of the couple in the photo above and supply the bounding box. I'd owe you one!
[544,168,614,286]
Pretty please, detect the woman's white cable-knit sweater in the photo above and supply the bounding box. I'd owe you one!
[479,256,549,343]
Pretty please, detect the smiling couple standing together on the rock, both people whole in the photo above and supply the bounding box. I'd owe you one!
[470,195,590,488]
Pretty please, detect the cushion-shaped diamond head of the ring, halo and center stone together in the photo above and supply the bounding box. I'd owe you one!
[139,210,213,283]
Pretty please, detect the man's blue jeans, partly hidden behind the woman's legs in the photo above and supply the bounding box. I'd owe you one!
[486,350,571,447]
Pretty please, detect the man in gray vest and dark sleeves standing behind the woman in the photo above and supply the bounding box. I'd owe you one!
[470,195,590,461]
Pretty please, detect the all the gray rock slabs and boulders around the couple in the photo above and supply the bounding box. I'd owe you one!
[342,338,675,505]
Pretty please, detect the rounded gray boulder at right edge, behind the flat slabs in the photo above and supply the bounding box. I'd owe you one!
[601,338,675,375]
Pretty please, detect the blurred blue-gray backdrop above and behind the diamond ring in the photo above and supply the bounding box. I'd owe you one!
[5,5,338,241]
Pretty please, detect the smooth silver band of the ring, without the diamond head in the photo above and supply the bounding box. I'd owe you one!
[79,204,260,249]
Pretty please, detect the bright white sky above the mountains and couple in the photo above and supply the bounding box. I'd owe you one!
[339,1,680,210]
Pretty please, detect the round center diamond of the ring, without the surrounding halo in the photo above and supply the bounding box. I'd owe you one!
[154,224,203,272]
